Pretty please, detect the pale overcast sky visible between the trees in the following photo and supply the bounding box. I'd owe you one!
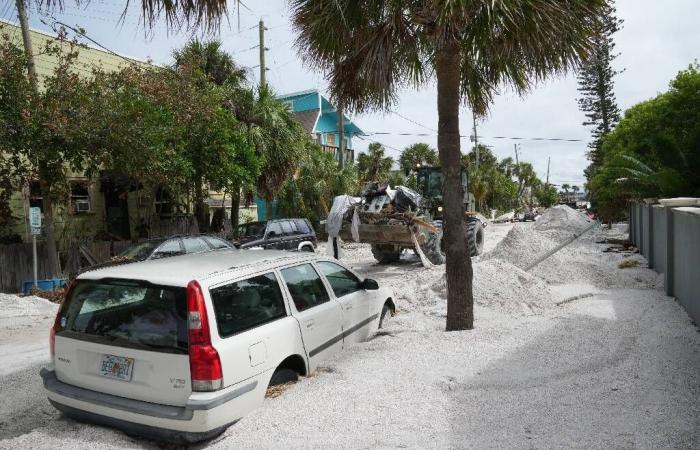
[6,0,700,185]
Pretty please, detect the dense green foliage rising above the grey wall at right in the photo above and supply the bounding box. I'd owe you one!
[589,64,700,221]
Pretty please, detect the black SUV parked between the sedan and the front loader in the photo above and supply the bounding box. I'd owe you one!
[235,219,318,252]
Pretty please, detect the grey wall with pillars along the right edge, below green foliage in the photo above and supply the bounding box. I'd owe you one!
[630,203,700,324]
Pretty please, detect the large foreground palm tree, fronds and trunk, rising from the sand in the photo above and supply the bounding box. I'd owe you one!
[291,0,605,330]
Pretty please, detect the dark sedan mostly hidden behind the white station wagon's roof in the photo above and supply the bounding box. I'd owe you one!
[115,234,234,262]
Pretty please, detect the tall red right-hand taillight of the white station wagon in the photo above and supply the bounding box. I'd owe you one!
[187,280,224,391]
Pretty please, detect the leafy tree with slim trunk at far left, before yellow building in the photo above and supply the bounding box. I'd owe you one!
[0,32,99,276]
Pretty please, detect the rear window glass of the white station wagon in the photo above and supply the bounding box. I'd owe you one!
[57,280,187,353]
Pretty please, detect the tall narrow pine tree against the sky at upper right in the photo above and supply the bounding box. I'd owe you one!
[578,3,622,180]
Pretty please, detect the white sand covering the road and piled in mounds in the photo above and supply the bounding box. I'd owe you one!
[0,210,700,449]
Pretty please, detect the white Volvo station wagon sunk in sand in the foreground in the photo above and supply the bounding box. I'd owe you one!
[41,250,394,442]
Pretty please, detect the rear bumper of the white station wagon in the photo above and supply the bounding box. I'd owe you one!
[40,369,265,443]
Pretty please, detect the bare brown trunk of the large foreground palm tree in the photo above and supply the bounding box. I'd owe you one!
[435,42,474,331]
